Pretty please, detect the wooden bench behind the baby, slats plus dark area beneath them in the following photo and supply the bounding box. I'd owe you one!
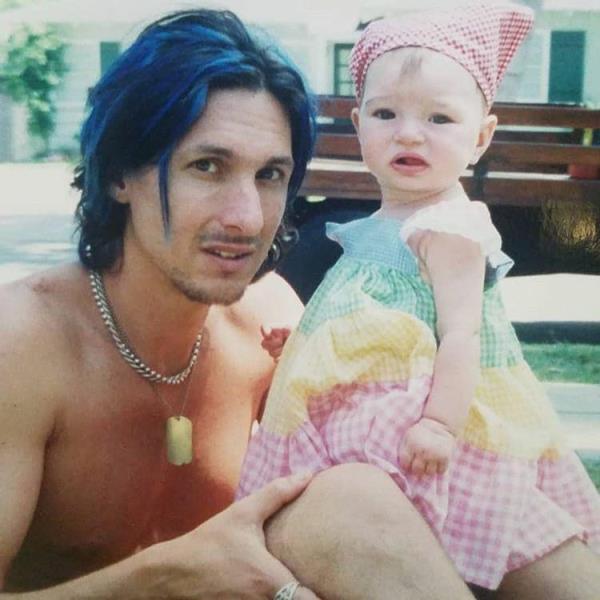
[279,96,600,301]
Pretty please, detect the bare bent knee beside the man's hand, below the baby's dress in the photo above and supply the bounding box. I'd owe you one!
[266,464,473,600]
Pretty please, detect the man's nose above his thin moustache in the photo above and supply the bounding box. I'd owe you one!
[221,178,264,236]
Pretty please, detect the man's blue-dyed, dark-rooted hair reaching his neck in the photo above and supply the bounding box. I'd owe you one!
[74,10,316,272]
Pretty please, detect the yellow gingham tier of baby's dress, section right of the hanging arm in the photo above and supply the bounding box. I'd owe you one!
[460,363,565,459]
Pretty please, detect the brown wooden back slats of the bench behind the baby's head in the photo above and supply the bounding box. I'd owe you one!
[300,96,600,207]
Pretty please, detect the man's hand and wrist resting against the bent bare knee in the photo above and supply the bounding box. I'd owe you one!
[142,476,318,600]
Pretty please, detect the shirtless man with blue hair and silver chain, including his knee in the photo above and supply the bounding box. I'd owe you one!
[0,10,588,600]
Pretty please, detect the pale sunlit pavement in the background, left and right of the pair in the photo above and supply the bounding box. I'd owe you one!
[0,163,600,457]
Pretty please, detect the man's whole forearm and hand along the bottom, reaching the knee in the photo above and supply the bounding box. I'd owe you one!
[0,476,317,600]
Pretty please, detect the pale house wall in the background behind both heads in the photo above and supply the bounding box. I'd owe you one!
[0,0,600,160]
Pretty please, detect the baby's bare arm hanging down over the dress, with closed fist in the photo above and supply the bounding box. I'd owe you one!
[400,231,485,474]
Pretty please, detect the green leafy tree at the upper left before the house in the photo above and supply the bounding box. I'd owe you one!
[0,25,67,153]
